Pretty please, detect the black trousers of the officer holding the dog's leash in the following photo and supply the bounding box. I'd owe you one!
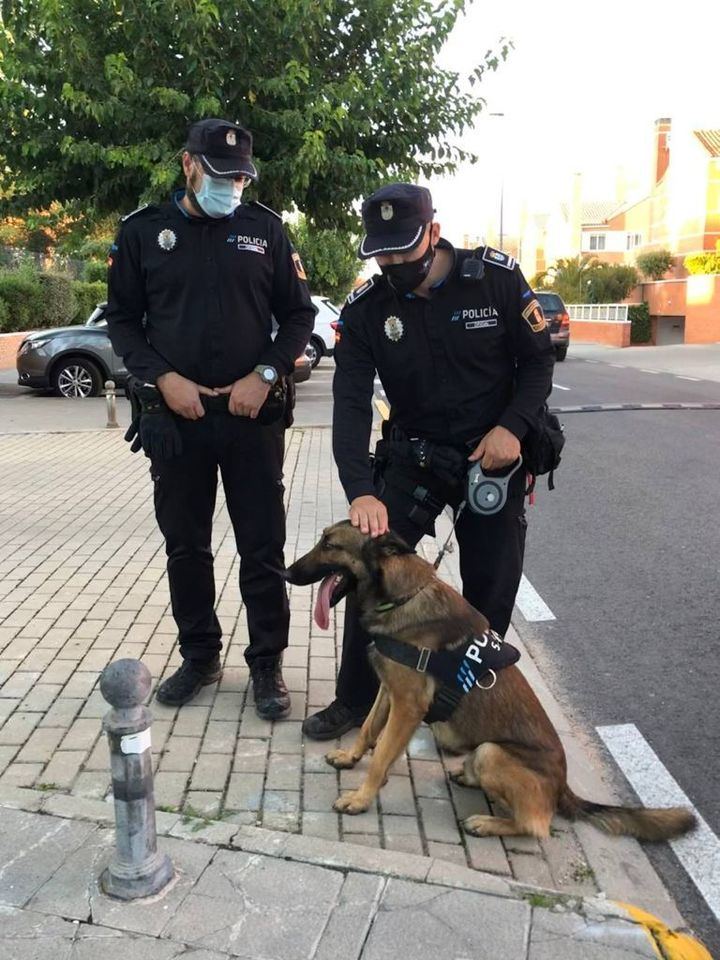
[336,465,527,711]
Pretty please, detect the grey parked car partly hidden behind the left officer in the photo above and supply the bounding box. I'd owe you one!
[16,303,312,399]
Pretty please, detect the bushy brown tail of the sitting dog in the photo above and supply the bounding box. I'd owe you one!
[558,785,697,840]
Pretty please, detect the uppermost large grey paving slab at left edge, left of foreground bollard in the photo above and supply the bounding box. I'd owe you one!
[0,809,96,907]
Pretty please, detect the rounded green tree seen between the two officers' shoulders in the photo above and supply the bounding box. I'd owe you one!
[290,217,359,303]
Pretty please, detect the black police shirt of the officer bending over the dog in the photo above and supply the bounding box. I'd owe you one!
[333,240,554,501]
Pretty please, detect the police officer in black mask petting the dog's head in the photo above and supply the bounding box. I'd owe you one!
[303,183,554,739]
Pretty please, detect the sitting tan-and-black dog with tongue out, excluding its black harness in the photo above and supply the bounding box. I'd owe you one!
[286,520,695,840]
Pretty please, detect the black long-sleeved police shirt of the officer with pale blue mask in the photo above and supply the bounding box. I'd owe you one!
[107,193,315,387]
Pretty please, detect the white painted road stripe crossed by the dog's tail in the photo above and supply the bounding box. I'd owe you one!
[597,723,720,919]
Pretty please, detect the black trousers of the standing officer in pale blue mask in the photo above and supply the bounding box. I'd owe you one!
[151,412,290,664]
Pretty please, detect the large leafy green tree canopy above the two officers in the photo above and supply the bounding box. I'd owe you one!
[0,0,508,229]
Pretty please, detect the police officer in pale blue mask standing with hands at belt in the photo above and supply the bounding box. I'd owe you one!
[107,119,314,718]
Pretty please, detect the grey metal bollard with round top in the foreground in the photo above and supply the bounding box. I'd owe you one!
[100,660,173,900]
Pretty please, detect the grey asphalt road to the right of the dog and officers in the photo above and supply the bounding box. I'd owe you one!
[515,347,720,955]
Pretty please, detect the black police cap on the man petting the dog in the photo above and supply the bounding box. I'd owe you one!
[358,183,435,260]
